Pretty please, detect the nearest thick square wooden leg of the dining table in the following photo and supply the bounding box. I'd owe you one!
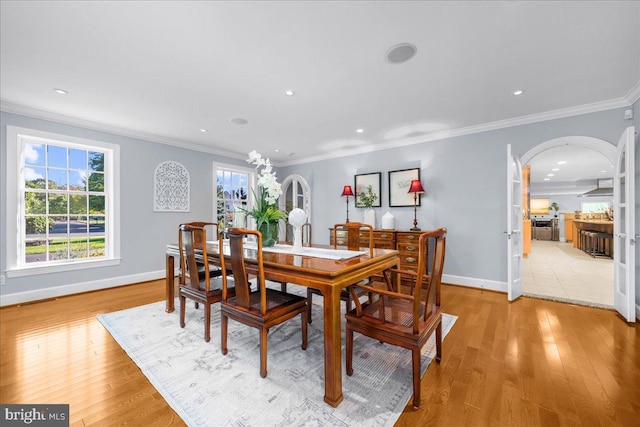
[322,286,343,407]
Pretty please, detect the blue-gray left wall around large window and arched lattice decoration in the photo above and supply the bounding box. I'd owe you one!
[0,113,246,302]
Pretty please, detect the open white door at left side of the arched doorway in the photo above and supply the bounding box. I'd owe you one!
[507,144,523,301]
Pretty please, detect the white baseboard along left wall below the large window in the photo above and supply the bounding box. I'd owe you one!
[0,270,166,307]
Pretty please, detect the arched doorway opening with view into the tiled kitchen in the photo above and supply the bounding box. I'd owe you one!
[522,138,614,308]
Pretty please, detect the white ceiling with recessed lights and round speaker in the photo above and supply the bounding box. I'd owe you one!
[0,1,640,165]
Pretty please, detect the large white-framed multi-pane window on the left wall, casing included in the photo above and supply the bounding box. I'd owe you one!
[7,126,119,276]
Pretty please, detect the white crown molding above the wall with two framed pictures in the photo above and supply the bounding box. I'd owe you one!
[279,96,640,166]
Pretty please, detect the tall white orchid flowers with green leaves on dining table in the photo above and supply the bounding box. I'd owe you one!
[245,150,286,234]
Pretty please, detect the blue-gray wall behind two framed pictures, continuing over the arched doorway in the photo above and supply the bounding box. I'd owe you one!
[279,108,640,294]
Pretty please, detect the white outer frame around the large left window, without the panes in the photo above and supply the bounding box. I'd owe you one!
[3,125,121,278]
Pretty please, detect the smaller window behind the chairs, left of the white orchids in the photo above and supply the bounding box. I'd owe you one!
[214,164,255,229]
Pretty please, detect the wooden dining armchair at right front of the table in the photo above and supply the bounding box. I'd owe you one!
[345,228,447,408]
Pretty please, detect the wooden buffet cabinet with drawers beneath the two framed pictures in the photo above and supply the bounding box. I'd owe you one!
[329,228,423,271]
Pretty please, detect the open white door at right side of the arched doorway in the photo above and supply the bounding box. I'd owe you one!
[613,126,636,322]
